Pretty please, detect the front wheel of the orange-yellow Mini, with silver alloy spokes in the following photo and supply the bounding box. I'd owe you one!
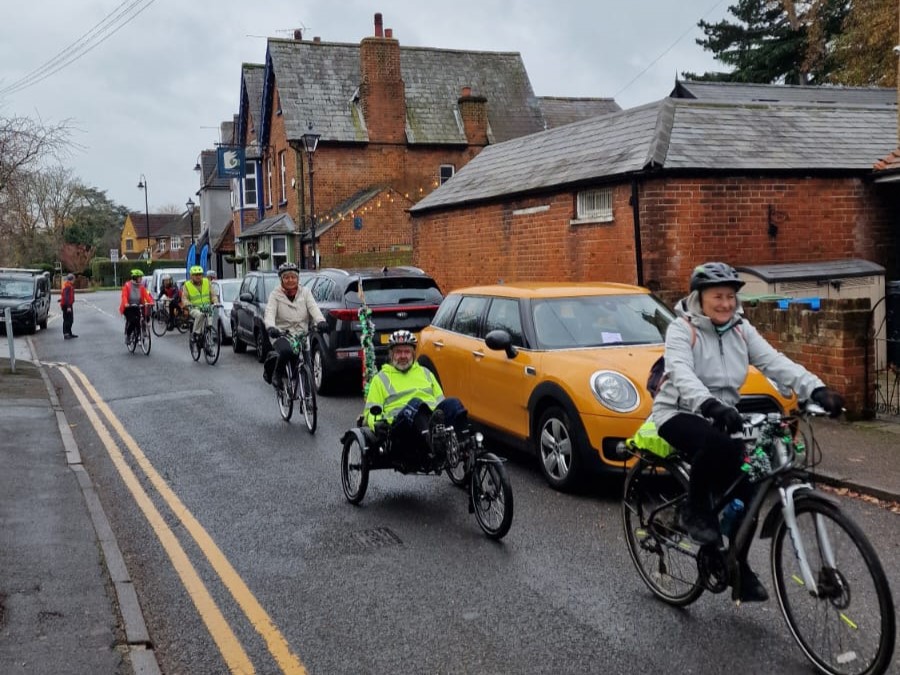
[534,405,584,492]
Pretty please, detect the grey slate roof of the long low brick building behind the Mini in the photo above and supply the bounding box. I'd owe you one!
[411,98,897,213]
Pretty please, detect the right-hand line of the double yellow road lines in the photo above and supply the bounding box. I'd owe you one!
[64,365,307,675]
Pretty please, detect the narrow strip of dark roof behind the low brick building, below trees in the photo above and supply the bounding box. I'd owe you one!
[670,80,897,108]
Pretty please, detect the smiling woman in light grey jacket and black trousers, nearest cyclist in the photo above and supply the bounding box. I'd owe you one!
[652,262,844,602]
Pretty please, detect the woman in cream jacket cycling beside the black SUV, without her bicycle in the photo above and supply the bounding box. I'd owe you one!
[263,262,328,387]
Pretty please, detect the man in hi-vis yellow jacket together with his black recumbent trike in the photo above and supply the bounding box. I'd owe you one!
[341,330,513,539]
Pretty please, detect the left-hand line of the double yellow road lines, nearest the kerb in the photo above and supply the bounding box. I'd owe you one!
[60,366,255,675]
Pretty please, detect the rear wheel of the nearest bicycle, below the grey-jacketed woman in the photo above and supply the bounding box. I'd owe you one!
[622,456,704,607]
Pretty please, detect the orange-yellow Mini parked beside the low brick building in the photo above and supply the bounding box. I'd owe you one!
[418,283,788,490]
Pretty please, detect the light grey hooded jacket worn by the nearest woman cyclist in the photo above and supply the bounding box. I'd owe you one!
[651,291,825,429]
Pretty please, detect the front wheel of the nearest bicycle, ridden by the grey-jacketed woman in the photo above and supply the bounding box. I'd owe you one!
[772,498,896,675]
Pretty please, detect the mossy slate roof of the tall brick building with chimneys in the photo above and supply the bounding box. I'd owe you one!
[263,38,545,145]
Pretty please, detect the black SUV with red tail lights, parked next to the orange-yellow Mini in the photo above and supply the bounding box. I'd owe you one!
[301,267,443,394]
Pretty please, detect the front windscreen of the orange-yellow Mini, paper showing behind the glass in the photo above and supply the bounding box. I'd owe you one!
[531,294,674,349]
